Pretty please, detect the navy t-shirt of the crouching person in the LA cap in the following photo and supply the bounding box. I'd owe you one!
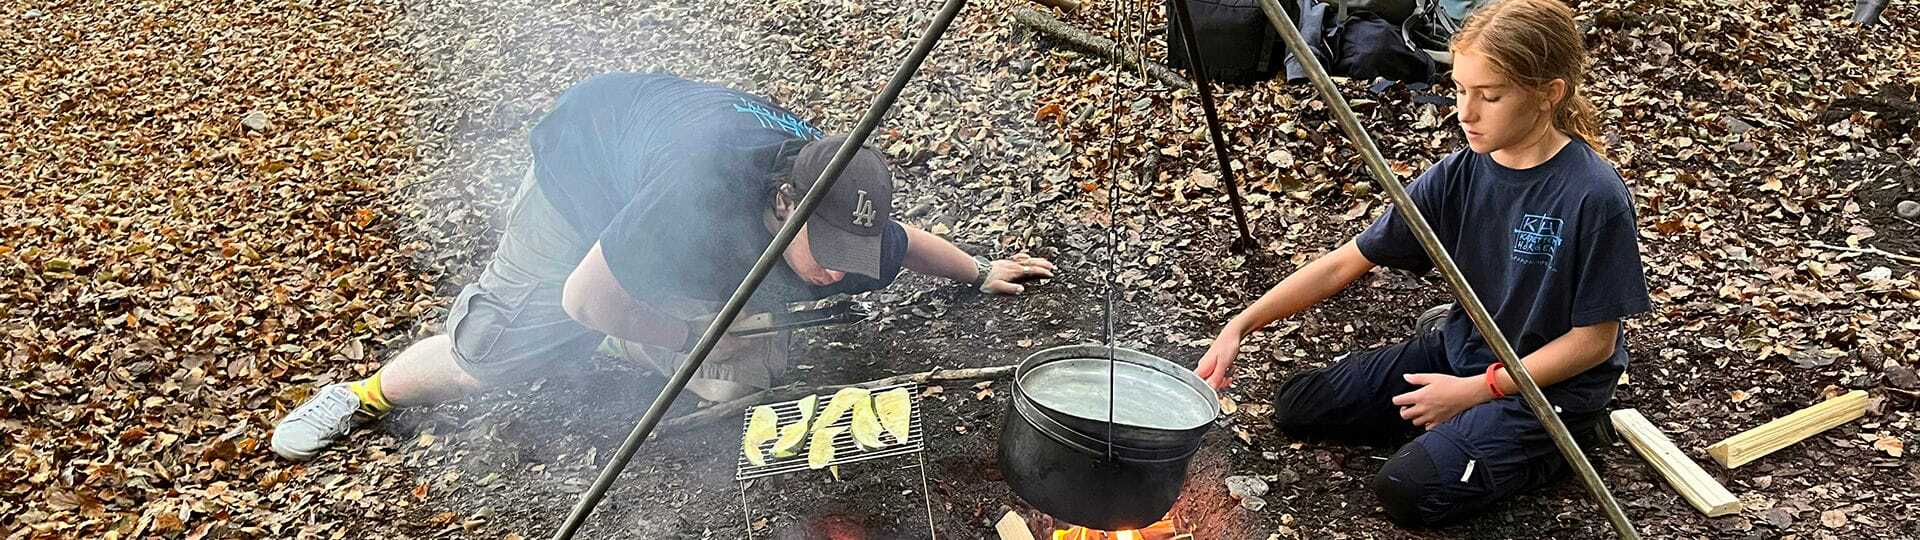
[528,73,906,307]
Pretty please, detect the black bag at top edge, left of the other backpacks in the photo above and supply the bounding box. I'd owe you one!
[1165,0,1292,85]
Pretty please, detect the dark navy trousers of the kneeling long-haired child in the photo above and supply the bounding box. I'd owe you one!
[1273,332,1605,527]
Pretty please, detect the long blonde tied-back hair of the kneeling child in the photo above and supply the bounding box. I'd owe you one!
[1448,0,1607,156]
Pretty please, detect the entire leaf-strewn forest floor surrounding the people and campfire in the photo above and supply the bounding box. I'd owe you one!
[0,0,1920,540]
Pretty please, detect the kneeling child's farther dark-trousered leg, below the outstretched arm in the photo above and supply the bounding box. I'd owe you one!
[1273,332,1448,444]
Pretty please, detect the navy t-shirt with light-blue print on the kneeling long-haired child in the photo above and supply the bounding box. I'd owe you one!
[1356,138,1651,411]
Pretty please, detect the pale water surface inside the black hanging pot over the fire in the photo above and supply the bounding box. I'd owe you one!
[1020,357,1215,430]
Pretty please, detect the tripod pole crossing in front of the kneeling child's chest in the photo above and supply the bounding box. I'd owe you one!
[1260,0,1640,540]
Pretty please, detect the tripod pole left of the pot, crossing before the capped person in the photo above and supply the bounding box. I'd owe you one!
[553,0,966,540]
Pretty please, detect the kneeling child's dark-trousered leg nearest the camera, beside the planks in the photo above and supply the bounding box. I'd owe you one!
[1373,396,1607,527]
